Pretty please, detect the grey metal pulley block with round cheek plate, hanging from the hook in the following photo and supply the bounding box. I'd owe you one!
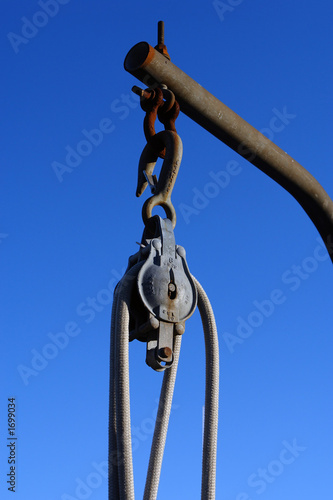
[137,216,197,371]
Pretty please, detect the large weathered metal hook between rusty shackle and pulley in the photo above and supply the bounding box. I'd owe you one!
[136,130,183,228]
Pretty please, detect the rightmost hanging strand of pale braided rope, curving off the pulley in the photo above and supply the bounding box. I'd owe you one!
[193,278,219,500]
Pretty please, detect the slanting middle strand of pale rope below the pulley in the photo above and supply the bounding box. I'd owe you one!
[143,335,182,500]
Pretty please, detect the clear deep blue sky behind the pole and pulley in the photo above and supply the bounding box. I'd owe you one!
[0,0,333,500]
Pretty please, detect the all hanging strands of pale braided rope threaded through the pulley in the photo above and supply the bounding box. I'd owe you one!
[109,262,219,500]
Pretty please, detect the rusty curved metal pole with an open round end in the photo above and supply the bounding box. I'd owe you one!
[124,42,333,262]
